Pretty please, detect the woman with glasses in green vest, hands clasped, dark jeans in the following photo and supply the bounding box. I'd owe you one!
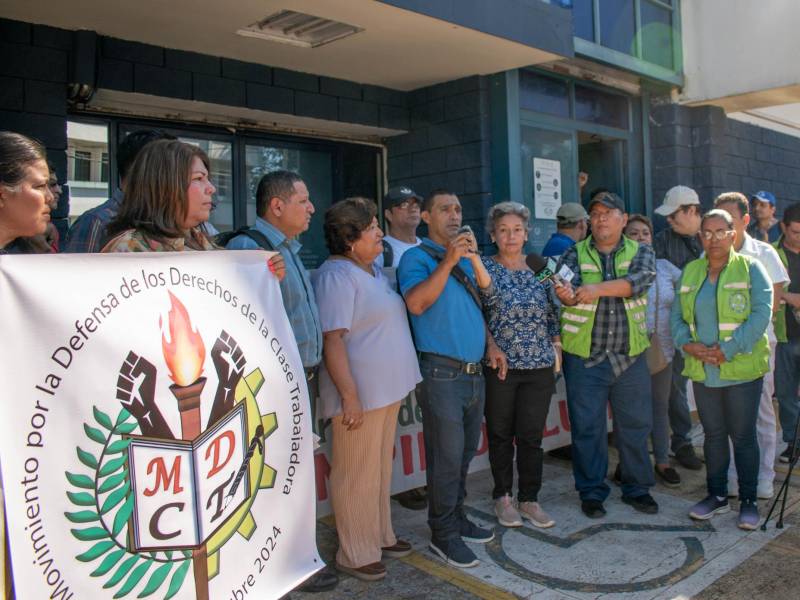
[670,209,772,530]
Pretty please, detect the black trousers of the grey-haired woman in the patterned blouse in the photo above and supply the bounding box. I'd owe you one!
[484,367,555,502]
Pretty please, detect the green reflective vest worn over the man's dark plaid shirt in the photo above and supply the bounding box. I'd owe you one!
[561,237,650,358]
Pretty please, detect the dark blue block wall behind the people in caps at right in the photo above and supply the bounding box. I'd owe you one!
[650,104,800,214]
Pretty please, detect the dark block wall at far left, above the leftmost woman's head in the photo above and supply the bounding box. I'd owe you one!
[0,19,73,234]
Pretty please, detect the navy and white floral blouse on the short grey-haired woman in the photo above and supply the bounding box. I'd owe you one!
[482,257,559,369]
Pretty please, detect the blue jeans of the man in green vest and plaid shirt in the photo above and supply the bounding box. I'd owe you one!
[564,352,655,502]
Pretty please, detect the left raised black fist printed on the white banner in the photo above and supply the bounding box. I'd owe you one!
[117,351,175,439]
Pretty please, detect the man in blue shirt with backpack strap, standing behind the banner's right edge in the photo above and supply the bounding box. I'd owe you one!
[226,171,339,593]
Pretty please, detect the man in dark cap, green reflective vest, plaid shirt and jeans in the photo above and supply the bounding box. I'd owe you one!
[555,192,658,519]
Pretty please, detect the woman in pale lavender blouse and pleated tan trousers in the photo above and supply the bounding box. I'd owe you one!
[312,198,422,581]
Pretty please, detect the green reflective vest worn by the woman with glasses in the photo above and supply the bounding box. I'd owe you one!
[678,250,769,381]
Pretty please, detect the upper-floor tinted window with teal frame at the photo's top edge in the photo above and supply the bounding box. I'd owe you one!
[572,0,680,71]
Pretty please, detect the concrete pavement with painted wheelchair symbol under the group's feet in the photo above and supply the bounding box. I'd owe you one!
[286,450,800,600]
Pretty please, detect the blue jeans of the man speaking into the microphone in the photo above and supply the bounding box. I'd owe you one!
[418,358,485,541]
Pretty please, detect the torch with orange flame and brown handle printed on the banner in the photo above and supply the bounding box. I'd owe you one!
[159,292,208,600]
